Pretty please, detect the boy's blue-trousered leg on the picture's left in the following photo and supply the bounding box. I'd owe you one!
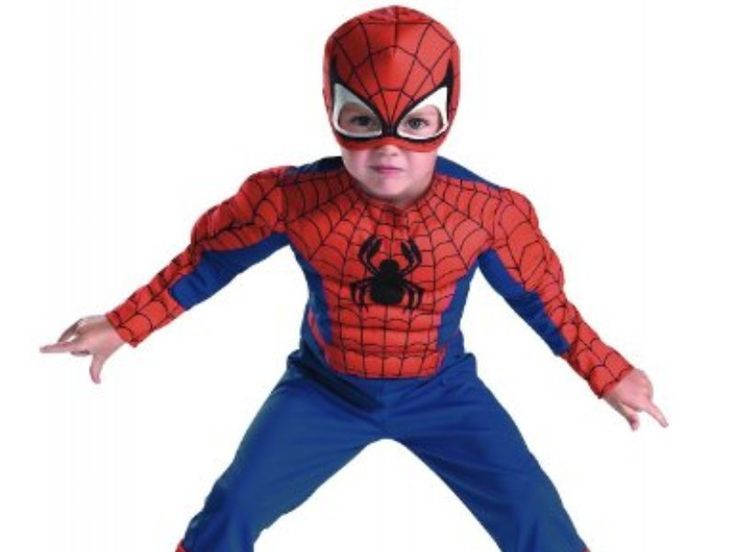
[177,367,380,552]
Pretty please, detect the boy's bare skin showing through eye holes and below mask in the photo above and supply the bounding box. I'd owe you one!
[339,103,442,207]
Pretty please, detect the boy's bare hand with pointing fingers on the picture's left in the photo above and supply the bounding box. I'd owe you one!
[39,315,125,383]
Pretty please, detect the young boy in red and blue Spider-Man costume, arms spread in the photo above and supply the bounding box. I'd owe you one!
[42,6,667,552]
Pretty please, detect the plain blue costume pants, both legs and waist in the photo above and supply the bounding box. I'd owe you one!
[178,351,587,552]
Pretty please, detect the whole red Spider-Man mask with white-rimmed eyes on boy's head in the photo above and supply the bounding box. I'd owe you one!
[322,6,460,152]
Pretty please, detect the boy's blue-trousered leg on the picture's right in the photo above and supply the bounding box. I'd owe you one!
[396,362,586,552]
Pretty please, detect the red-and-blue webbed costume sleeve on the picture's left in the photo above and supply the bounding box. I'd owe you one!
[105,166,289,347]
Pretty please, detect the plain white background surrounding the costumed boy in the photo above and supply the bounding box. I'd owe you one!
[0,0,736,552]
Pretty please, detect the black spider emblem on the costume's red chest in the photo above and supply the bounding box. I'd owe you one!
[350,236,424,310]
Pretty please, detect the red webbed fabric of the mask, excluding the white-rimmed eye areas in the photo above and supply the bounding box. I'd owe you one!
[322,6,460,151]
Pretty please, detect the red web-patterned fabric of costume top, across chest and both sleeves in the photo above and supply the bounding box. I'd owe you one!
[106,155,633,397]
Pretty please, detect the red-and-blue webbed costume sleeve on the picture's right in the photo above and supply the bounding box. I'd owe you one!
[479,189,633,397]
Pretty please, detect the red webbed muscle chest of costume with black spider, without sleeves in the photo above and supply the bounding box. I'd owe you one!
[283,169,493,377]
